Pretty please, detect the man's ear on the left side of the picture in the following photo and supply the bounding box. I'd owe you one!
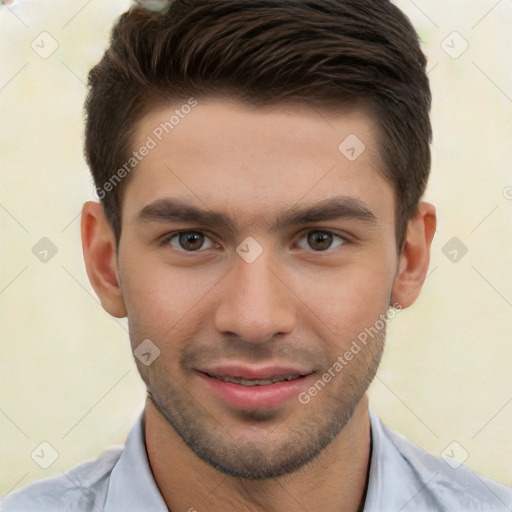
[81,201,126,318]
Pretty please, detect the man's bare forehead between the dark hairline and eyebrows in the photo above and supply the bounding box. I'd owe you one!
[123,99,394,227]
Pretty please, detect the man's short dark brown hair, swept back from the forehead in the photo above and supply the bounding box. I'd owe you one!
[85,0,432,248]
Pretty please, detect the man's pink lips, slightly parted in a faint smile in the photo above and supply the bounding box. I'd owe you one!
[198,364,312,410]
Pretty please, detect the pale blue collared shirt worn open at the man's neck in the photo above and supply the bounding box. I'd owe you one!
[0,409,512,512]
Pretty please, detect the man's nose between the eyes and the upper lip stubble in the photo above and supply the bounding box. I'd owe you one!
[215,251,296,344]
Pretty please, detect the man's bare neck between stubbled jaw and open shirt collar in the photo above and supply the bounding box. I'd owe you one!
[145,395,370,512]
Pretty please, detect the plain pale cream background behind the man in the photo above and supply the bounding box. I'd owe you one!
[0,0,512,495]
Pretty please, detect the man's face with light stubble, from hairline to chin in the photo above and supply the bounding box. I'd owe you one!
[118,100,397,478]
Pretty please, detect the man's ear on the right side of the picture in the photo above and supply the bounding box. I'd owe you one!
[391,202,437,308]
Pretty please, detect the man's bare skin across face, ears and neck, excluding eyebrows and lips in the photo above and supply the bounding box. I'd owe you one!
[82,98,436,512]
